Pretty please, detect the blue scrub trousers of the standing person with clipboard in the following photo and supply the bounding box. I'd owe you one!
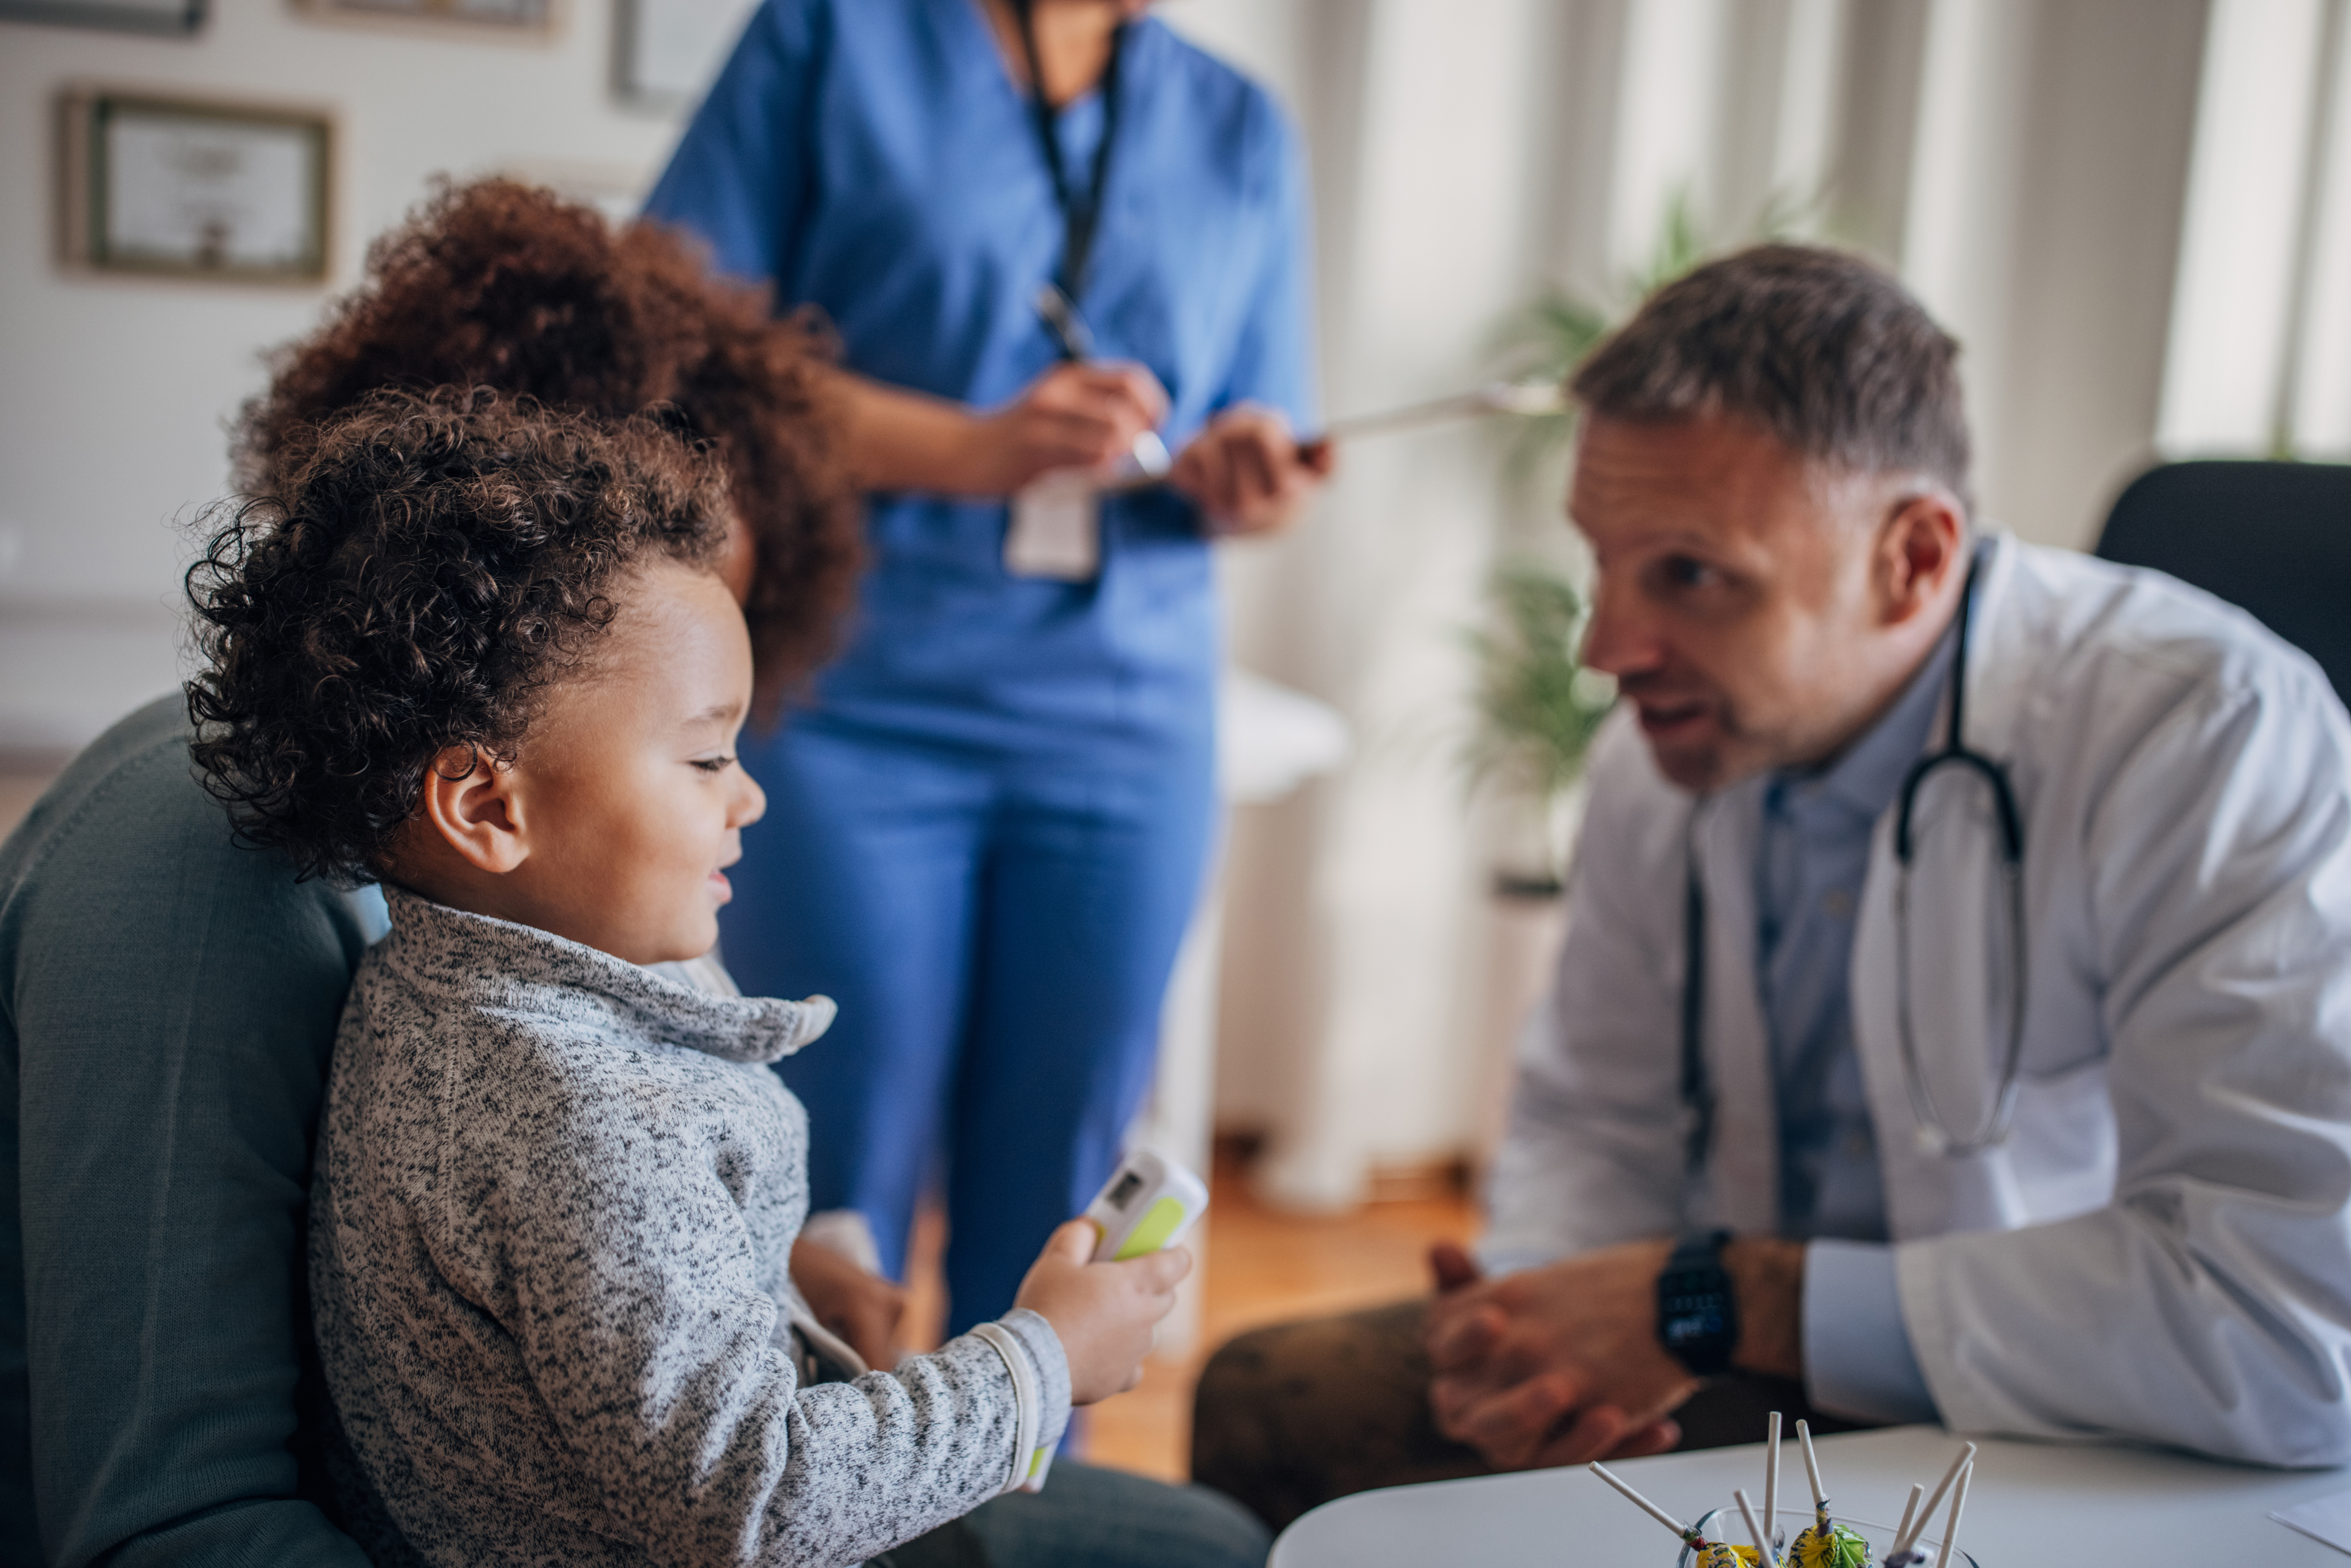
[721,715,1216,1333]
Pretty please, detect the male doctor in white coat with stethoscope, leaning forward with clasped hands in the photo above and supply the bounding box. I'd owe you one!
[1194,244,2351,1523]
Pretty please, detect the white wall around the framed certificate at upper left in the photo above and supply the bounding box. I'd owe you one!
[0,0,696,752]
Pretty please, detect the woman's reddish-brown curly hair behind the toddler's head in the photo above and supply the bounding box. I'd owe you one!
[238,178,863,715]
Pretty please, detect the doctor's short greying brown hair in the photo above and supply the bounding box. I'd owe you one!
[1568,244,1973,510]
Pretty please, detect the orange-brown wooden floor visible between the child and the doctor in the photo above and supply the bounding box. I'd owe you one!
[907,1154,1476,1481]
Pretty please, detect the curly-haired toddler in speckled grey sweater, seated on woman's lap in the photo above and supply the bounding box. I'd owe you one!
[191,393,1185,1566]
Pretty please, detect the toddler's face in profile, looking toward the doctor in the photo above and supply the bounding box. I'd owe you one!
[444,562,766,964]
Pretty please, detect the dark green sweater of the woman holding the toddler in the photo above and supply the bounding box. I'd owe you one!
[0,696,383,1568]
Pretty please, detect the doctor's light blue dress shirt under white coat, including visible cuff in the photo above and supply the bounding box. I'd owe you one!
[1756,628,1956,1420]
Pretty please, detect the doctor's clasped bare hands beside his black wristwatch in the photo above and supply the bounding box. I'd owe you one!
[1422,1241,1697,1469]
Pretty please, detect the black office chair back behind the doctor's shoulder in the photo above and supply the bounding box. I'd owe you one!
[2097,463,2351,703]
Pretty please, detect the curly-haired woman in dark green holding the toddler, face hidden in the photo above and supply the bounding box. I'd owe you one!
[0,181,1263,1568]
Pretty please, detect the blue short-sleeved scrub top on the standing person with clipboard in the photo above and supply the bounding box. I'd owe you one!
[646,0,1312,755]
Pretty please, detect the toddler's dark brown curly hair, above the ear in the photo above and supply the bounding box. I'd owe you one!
[188,390,729,886]
